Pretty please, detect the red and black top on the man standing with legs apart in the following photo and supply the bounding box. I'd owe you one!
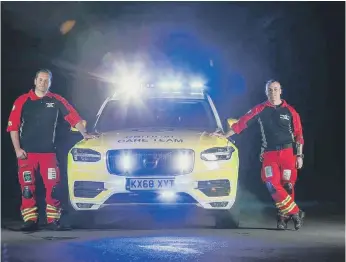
[7,90,82,153]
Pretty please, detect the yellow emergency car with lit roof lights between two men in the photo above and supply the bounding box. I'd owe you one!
[67,79,239,228]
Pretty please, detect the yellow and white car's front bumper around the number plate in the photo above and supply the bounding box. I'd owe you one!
[69,170,238,210]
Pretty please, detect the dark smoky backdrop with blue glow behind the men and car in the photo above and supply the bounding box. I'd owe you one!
[1,2,345,221]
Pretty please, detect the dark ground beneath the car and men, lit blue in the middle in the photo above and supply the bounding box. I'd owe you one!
[2,203,345,262]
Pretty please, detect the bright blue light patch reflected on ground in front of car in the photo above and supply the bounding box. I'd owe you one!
[67,237,227,262]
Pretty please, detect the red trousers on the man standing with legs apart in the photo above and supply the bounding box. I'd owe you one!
[18,153,61,223]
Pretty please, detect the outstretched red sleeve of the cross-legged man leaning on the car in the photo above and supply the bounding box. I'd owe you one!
[225,104,265,138]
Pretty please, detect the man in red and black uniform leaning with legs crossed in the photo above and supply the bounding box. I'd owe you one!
[213,80,305,230]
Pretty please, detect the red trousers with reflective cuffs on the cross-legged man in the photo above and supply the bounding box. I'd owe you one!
[261,148,299,215]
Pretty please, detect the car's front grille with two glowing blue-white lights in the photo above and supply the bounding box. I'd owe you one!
[107,149,194,176]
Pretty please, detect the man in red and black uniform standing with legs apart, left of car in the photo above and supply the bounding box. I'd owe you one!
[7,69,93,231]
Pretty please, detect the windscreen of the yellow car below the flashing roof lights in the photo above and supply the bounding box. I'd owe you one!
[96,98,217,133]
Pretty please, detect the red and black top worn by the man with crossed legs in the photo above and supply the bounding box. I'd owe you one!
[232,100,304,149]
